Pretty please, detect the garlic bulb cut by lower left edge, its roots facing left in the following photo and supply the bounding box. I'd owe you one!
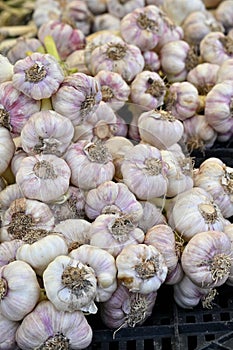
[0,261,40,321]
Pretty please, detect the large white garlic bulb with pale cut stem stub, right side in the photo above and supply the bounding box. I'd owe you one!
[168,187,228,241]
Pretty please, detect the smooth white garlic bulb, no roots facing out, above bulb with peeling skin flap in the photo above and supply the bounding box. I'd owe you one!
[16,230,68,276]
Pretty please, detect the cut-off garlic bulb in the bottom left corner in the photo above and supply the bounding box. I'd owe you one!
[0,314,20,350]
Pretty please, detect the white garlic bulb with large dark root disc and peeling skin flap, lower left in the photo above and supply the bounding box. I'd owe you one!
[43,255,97,313]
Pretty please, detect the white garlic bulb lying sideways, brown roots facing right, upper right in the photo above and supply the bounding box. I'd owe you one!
[159,40,200,83]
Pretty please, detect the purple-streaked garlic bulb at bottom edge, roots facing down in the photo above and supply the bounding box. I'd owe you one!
[16,301,93,350]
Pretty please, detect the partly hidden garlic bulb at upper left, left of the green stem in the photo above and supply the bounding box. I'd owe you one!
[7,36,42,64]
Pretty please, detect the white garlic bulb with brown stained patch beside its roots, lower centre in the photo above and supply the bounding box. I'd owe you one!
[116,243,168,294]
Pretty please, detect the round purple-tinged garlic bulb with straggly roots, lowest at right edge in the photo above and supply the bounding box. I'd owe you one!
[181,230,231,288]
